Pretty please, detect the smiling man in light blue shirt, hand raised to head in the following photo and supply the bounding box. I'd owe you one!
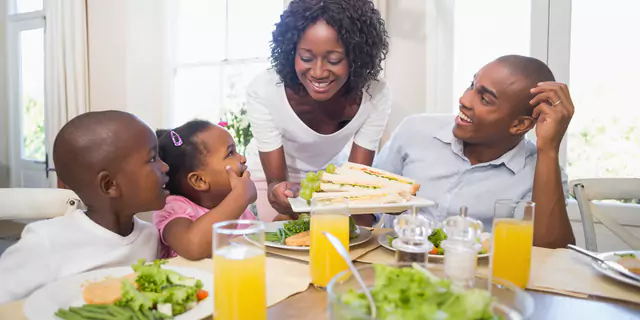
[374,55,575,248]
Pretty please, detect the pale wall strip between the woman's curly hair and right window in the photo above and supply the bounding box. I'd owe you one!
[381,0,427,143]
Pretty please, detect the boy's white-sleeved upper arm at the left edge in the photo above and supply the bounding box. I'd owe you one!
[0,226,56,304]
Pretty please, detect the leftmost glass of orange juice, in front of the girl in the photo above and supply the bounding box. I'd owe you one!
[213,220,267,320]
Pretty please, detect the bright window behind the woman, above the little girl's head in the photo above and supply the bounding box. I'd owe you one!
[171,0,284,126]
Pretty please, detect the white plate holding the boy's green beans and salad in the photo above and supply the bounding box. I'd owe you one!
[24,265,213,320]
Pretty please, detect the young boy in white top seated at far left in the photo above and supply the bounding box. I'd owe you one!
[0,111,168,303]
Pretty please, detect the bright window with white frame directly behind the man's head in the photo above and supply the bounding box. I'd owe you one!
[427,0,546,113]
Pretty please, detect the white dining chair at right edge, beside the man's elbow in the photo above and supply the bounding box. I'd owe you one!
[569,178,640,252]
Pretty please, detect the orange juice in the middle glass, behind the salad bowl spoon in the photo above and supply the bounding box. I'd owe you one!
[309,214,349,288]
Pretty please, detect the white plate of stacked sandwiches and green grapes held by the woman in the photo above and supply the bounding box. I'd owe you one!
[289,162,435,214]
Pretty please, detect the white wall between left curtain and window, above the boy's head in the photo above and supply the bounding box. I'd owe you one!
[87,0,172,128]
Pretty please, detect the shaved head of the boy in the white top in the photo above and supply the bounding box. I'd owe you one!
[53,111,169,236]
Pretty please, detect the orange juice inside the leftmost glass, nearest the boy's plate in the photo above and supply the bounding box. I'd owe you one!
[213,245,267,320]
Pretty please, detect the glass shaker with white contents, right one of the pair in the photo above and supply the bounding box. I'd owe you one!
[440,207,484,287]
